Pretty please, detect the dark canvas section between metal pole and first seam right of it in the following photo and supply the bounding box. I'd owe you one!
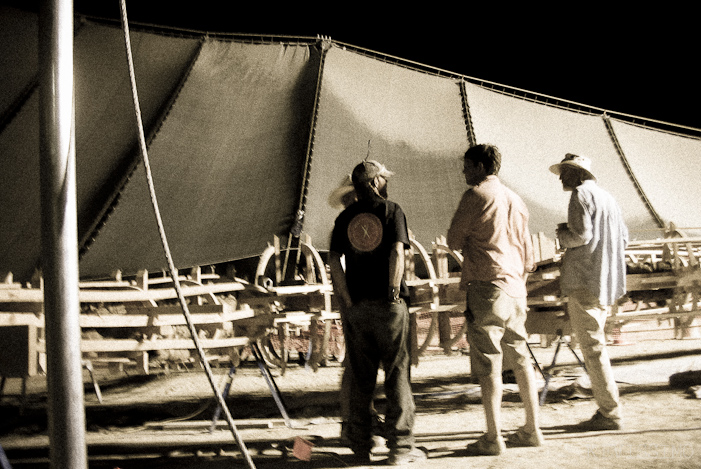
[74,23,200,245]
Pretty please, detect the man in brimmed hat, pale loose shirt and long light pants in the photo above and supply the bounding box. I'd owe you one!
[550,153,628,431]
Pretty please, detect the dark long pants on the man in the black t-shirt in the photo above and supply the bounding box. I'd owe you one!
[343,300,415,453]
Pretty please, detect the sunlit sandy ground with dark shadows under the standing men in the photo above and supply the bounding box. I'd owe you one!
[0,339,701,469]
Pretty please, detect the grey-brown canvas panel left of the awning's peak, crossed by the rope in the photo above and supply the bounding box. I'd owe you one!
[81,40,318,277]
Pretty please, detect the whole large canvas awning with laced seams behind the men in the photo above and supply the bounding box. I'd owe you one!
[0,6,701,280]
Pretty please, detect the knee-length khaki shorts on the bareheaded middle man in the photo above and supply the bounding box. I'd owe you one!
[467,282,530,377]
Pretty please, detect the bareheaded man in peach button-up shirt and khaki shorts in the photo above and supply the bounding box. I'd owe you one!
[447,145,543,455]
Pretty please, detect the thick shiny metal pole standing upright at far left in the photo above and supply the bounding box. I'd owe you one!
[39,0,87,469]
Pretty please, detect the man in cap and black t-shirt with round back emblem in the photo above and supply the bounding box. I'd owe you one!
[329,160,425,465]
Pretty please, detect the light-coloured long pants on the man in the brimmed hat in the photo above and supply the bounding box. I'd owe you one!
[567,290,621,419]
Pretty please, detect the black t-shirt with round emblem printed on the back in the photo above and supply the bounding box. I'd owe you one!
[330,199,409,302]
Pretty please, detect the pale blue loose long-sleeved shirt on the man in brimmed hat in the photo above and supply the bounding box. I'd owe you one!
[560,180,628,305]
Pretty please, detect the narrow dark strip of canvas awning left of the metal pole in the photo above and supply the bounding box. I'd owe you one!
[0,6,40,280]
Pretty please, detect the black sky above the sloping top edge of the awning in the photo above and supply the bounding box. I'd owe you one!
[68,0,701,128]
